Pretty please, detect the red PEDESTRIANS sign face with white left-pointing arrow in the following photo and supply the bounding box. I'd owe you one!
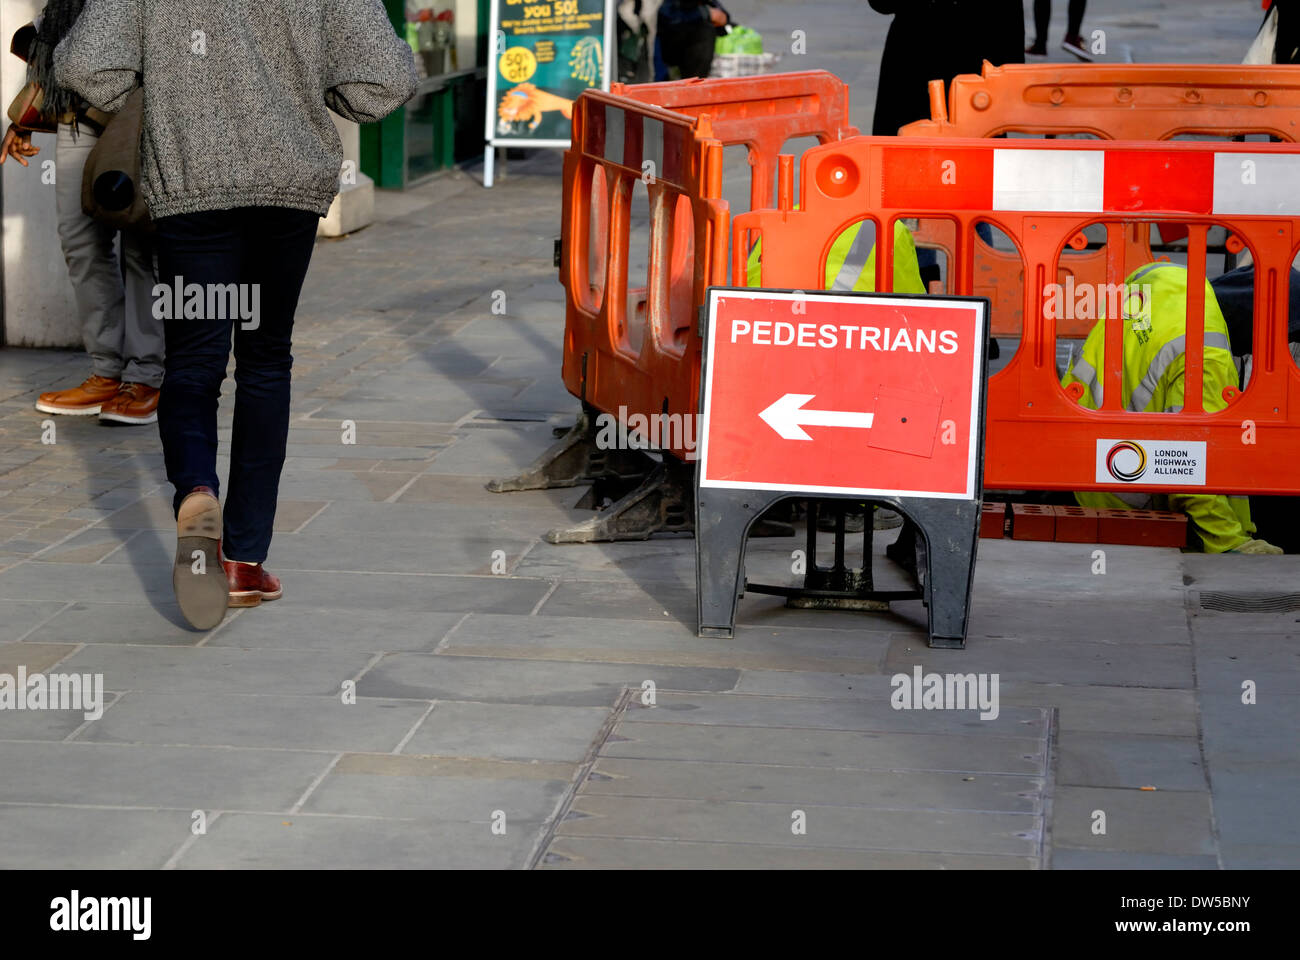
[698,287,988,500]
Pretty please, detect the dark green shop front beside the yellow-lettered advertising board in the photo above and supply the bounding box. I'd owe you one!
[361,0,490,190]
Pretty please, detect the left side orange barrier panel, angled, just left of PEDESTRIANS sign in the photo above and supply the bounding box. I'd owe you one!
[560,91,731,459]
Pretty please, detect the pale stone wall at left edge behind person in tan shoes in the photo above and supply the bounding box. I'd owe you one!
[0,0,82,346]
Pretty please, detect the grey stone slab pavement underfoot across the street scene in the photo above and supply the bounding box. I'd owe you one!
[0,0,1300,869]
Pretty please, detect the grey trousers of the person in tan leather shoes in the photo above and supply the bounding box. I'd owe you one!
[55,124,164,386]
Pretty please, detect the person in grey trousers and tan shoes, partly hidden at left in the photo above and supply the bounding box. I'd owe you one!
[0,0,164,424]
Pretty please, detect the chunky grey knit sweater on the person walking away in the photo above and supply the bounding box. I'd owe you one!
[55,0,416,219]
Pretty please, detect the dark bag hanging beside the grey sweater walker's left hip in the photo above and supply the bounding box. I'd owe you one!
[82,90,153,230]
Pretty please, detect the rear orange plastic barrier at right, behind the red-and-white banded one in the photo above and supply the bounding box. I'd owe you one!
[898,62,1300,337]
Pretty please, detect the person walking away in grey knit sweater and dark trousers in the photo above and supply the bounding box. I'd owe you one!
[55,0,416,630]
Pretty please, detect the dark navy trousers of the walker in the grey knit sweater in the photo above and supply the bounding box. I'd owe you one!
[156,207,320,563]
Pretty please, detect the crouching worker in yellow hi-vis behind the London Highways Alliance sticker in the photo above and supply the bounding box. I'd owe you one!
[1061,263,1282,553]
